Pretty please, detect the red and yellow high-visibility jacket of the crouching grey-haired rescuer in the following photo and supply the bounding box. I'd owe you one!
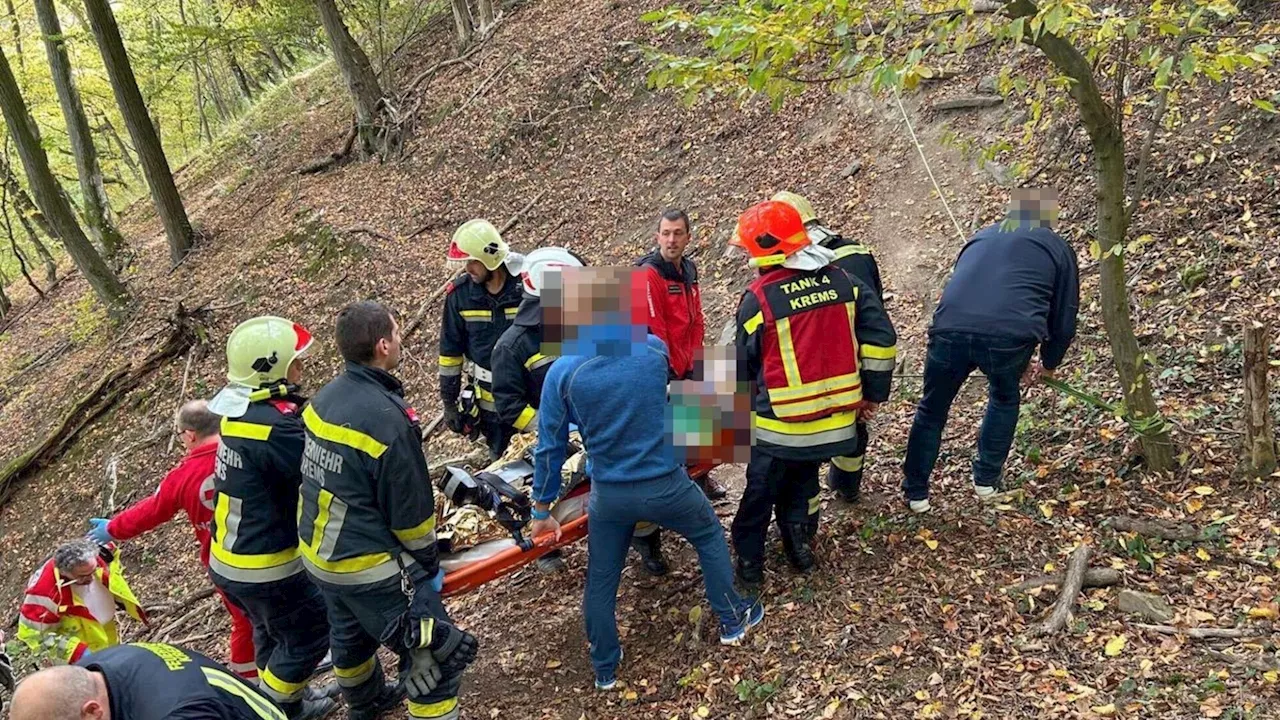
[18,555,146,662]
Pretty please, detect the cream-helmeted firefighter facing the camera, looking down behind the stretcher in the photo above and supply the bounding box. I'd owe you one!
[440,215,521,460]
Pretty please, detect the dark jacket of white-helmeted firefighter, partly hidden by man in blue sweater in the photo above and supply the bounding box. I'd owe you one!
[493,295,558,432]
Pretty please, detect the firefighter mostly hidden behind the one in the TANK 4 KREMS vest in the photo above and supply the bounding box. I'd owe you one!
[772,191,893,502]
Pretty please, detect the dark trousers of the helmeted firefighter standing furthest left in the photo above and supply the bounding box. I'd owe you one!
[210,573,329,712]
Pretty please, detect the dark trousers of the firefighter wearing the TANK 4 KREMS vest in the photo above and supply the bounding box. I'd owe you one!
[731,446,822,564]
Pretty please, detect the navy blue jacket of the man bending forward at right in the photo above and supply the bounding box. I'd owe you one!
[929,223,1080,370]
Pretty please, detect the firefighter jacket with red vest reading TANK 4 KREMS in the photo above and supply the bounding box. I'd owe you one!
[736,265,897,460]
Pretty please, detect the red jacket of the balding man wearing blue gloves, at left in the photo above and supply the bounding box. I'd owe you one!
[106,437,218,568]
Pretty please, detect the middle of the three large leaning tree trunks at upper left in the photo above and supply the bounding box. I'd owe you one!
[33,0,124,260]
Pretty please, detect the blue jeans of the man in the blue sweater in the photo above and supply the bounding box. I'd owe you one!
[582,468,750,676]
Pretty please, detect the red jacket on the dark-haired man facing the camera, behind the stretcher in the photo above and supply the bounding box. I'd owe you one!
[636,250,707,379]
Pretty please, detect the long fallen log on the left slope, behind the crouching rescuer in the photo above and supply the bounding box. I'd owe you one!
[0,304,202,507]
